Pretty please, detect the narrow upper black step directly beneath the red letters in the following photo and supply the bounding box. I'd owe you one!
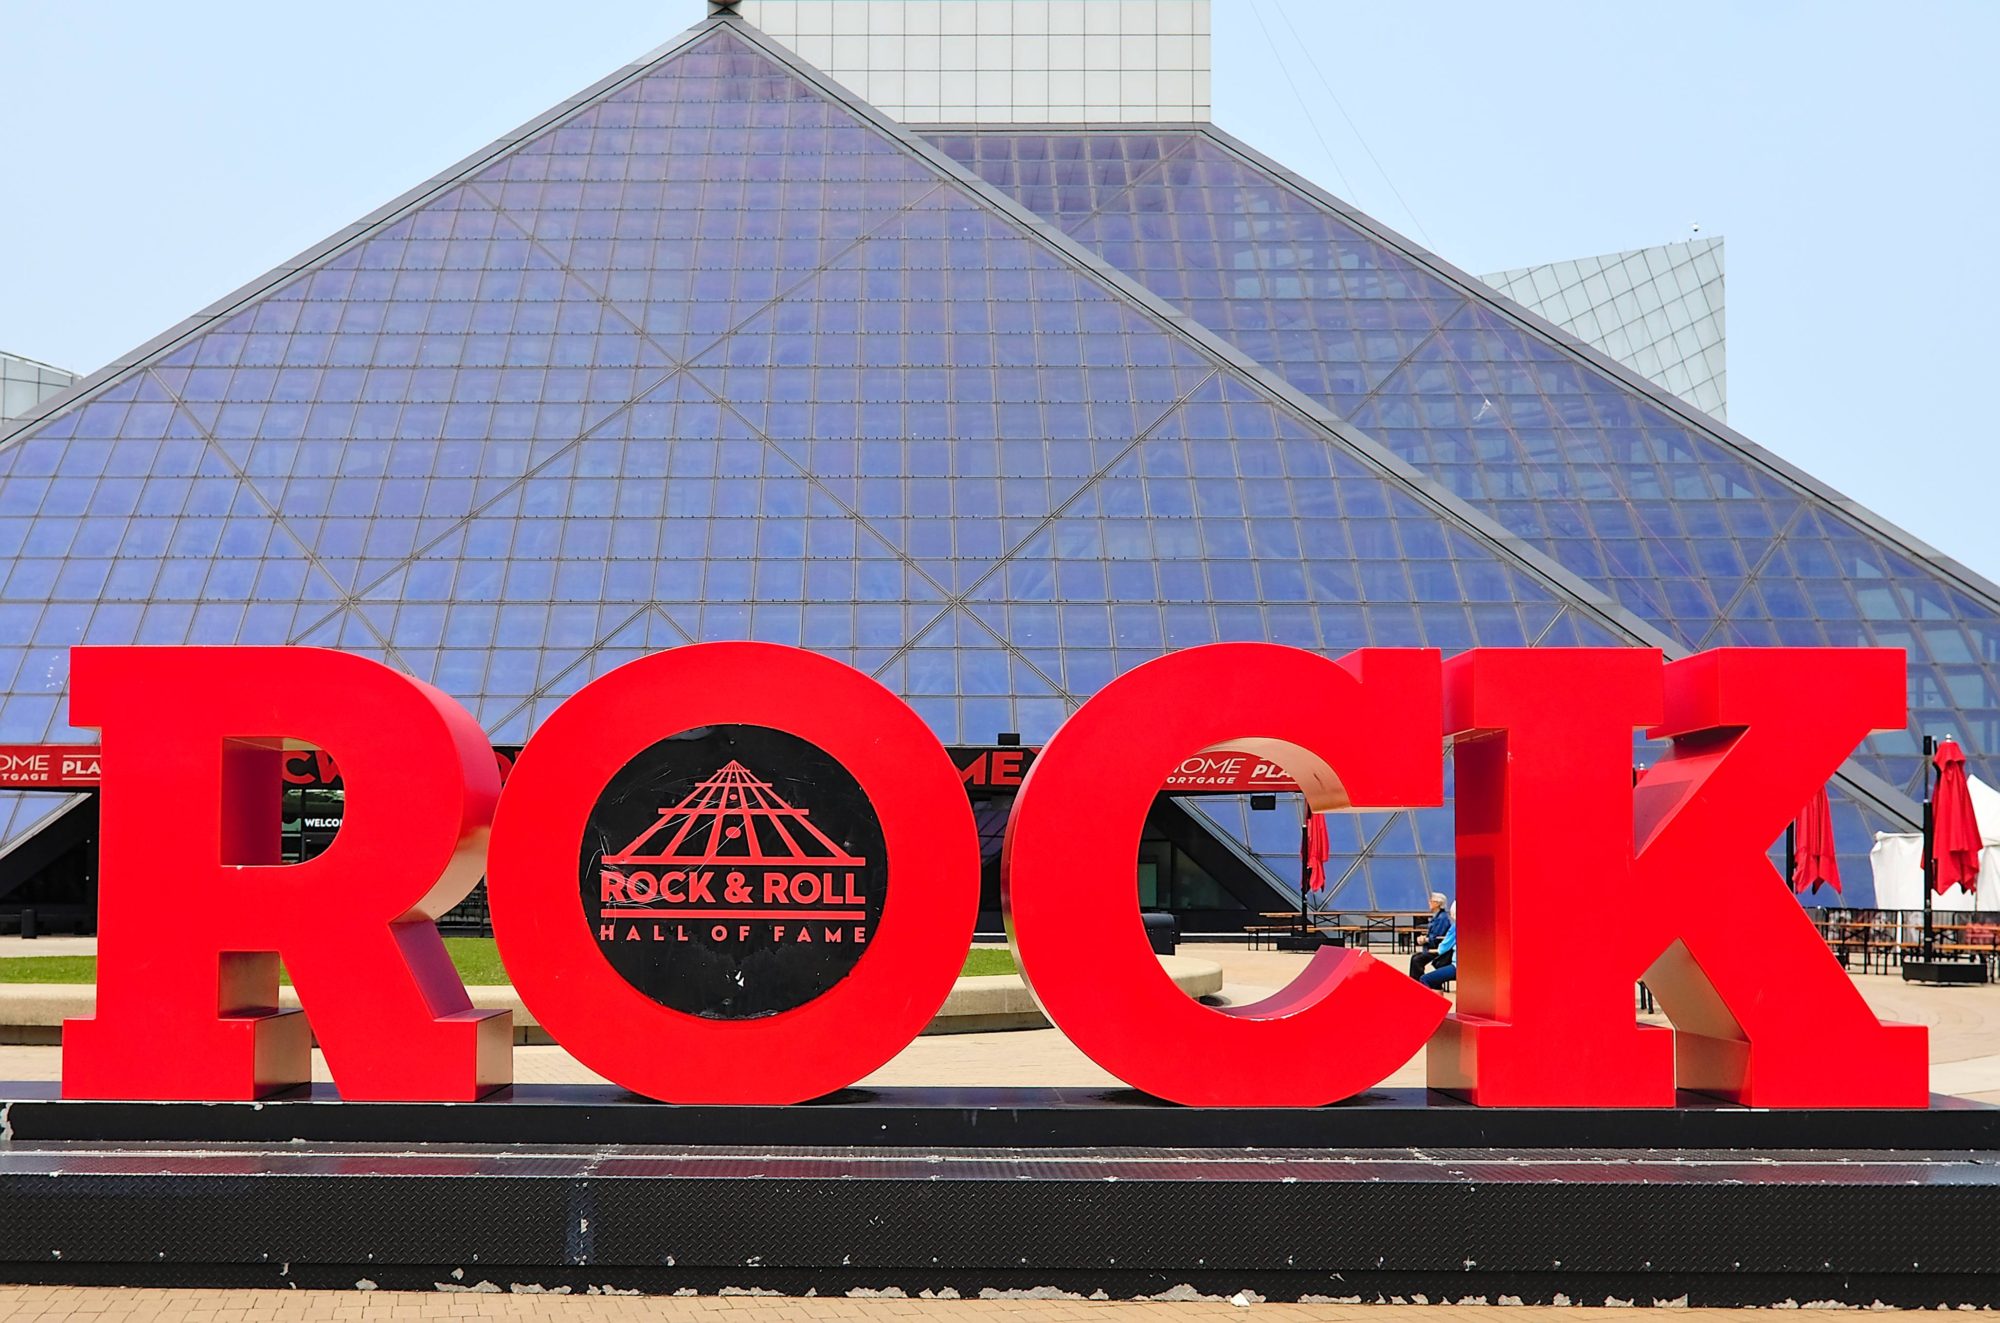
[15,1083,2000,1151]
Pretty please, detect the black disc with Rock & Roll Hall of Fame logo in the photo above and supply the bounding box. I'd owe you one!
[578,725,888,1019]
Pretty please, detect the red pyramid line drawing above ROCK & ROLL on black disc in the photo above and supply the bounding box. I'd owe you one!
[604,759,868,869]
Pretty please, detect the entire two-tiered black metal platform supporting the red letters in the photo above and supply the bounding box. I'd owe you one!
[11,1085,2000,1307]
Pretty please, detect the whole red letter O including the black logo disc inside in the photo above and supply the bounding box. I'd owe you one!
[486,644,980,1103]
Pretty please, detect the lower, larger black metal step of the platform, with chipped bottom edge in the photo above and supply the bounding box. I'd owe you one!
[0,1141,2000,1305]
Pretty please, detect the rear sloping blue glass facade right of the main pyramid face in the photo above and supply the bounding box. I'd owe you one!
[936,128,2000,807]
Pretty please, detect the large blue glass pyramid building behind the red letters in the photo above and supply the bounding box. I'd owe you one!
[0,18,2000,907]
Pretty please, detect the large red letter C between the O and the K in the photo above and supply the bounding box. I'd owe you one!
[1000,644,1446,1107]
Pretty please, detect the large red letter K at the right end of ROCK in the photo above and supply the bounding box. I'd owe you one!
[1430,648,1930,1107]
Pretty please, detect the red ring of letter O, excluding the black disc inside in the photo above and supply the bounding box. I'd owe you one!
[486,644,980,1103]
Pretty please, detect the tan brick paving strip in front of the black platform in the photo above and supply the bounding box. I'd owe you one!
[0,1287,1896,1323]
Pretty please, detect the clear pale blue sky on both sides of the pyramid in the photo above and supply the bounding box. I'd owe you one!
[0,0,2000,578]
